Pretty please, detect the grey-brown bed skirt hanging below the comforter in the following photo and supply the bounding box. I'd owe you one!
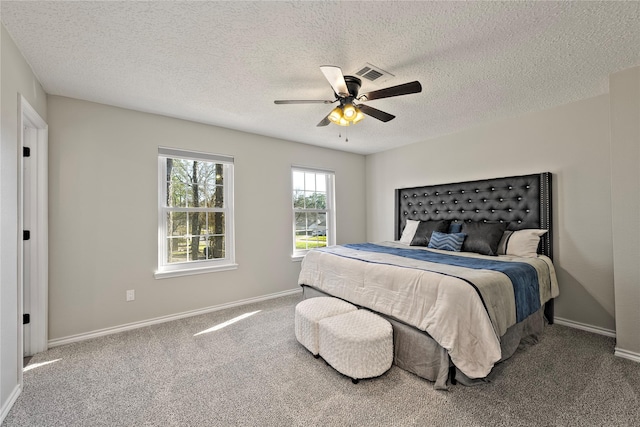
[302,285,544,390]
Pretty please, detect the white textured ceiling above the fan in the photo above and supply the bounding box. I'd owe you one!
[0,0,640,154]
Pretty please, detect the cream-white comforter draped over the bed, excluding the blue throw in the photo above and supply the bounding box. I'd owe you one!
[298,242,559,378]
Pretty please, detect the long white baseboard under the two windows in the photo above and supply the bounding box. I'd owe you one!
[49,288,302,347]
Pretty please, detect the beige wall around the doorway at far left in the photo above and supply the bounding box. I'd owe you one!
[0,25,47,420]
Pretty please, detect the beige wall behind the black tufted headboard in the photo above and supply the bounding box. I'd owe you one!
[366,95,615,331]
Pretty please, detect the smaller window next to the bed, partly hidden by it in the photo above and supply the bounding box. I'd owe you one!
[292,167,335,257]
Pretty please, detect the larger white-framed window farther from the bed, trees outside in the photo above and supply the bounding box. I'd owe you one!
[155,147,237,278]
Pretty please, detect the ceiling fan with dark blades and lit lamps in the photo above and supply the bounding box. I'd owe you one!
[274,65,422,126]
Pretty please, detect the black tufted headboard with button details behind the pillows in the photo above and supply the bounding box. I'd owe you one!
[395,172,553,259]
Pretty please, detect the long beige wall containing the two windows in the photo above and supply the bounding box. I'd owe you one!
[48,96,366,340]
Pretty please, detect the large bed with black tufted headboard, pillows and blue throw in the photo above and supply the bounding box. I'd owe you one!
[299,172,559,389]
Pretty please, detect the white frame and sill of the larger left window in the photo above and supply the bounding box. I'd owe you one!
[154,147,238,279]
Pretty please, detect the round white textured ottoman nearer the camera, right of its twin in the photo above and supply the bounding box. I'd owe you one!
[319,310,393,383]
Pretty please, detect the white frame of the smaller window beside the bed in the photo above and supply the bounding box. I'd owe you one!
[290,165,336,261]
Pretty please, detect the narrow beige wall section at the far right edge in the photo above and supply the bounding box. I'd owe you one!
[609,67,640,361]
